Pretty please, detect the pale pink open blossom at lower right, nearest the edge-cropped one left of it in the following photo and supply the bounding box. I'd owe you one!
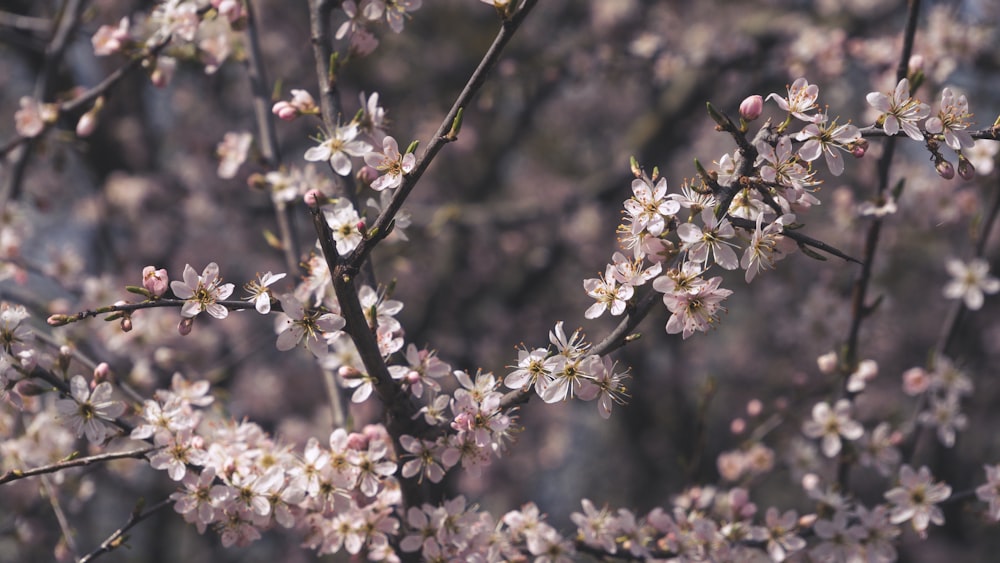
[885,465,951,537]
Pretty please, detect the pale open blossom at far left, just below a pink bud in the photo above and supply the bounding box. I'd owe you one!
[56,375,125,444]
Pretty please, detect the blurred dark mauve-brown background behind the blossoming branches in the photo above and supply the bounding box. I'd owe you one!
[0,0,1000,563]
